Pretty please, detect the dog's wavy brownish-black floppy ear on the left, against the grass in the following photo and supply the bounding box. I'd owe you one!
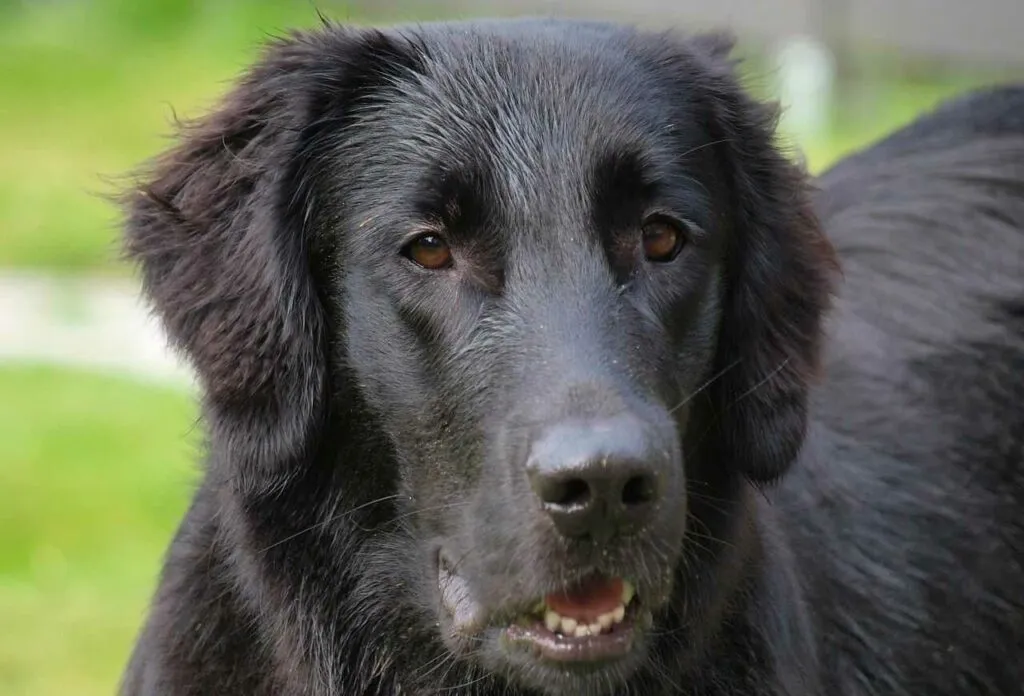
[125,28,419,491]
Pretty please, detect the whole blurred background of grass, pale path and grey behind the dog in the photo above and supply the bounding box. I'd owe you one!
[0,0,1024,696]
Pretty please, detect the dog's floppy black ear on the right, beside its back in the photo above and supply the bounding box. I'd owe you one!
[675,35,838,483]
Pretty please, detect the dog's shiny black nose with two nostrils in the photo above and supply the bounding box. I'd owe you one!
[526,417,671,541]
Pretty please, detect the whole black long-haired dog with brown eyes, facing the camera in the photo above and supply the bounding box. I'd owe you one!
[123,20,1024,696]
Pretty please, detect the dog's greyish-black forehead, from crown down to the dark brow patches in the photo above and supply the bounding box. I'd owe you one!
[339,21,707,228]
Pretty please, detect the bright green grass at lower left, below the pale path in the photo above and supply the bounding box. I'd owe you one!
[0,366,200,696]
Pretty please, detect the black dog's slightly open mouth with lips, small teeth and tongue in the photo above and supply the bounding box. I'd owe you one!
[438,558,645,663]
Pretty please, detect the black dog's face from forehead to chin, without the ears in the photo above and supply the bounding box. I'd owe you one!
[339,27,728,684]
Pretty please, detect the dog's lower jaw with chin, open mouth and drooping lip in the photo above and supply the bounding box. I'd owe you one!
[437,555,667,695]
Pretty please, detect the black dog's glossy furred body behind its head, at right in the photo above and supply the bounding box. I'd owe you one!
[779,88,1024,695]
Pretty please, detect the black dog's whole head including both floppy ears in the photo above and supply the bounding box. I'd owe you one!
[127,21,833,693]
